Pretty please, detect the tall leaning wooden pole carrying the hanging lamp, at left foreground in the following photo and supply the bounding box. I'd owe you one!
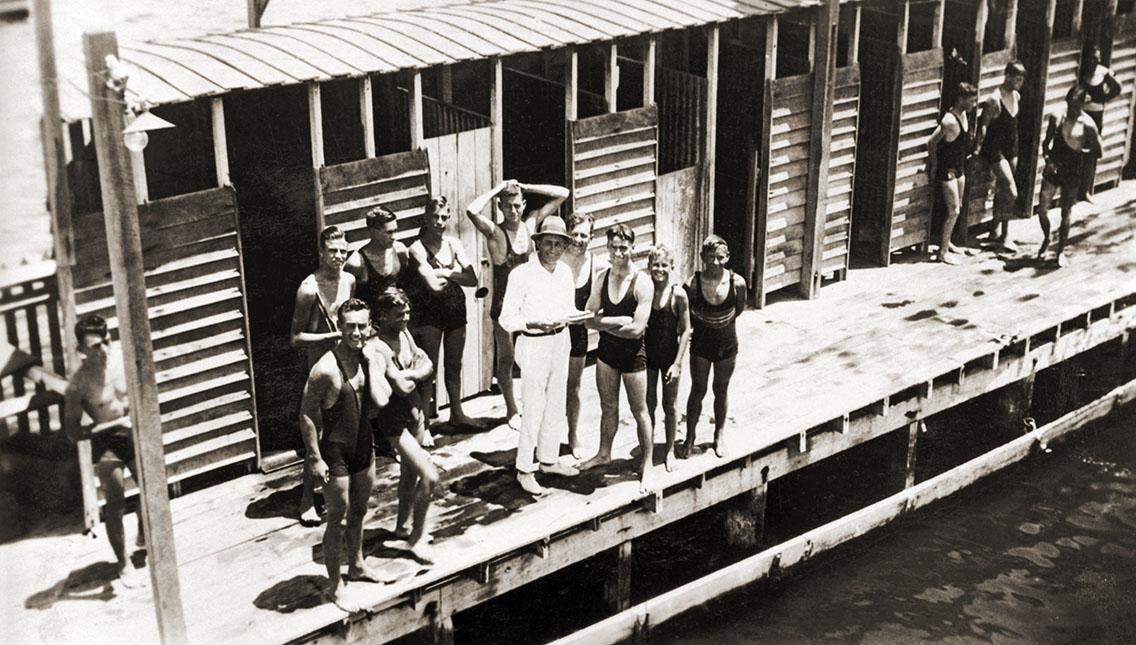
[83,32,186,644]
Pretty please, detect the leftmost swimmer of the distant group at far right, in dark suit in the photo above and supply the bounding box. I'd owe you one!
[927,83,978,265]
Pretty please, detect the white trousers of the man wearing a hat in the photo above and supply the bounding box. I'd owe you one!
[513,330,571,472]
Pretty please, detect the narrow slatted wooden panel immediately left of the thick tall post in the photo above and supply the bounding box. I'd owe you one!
[758,74,812,293]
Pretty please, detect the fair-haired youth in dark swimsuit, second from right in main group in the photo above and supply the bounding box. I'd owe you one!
[643,244,691,472]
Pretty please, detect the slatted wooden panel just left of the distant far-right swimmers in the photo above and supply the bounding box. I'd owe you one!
[888,49,943,251]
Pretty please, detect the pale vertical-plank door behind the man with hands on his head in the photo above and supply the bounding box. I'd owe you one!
[425,127,493,405]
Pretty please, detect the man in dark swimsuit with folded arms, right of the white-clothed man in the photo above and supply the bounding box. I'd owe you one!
[580,224,654,492]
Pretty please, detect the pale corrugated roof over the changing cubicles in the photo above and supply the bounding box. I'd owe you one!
[60,0,820,120]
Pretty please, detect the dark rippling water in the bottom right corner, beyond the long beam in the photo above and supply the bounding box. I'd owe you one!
[651,409,1136,644]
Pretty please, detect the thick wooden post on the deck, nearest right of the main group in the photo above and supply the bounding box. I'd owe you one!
[799,0,841,299]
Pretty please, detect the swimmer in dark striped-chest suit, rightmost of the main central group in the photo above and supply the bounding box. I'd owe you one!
[679,235,745,456]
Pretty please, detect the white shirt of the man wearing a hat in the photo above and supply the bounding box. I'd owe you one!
[498,253,576,332]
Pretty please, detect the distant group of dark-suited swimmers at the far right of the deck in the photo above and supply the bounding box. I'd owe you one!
[927,49,1120,267]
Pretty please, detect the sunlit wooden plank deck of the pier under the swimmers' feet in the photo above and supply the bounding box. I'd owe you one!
[0,184,1136,643]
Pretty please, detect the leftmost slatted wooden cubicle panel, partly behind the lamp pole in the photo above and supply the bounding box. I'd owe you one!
[74,187,258,481]
